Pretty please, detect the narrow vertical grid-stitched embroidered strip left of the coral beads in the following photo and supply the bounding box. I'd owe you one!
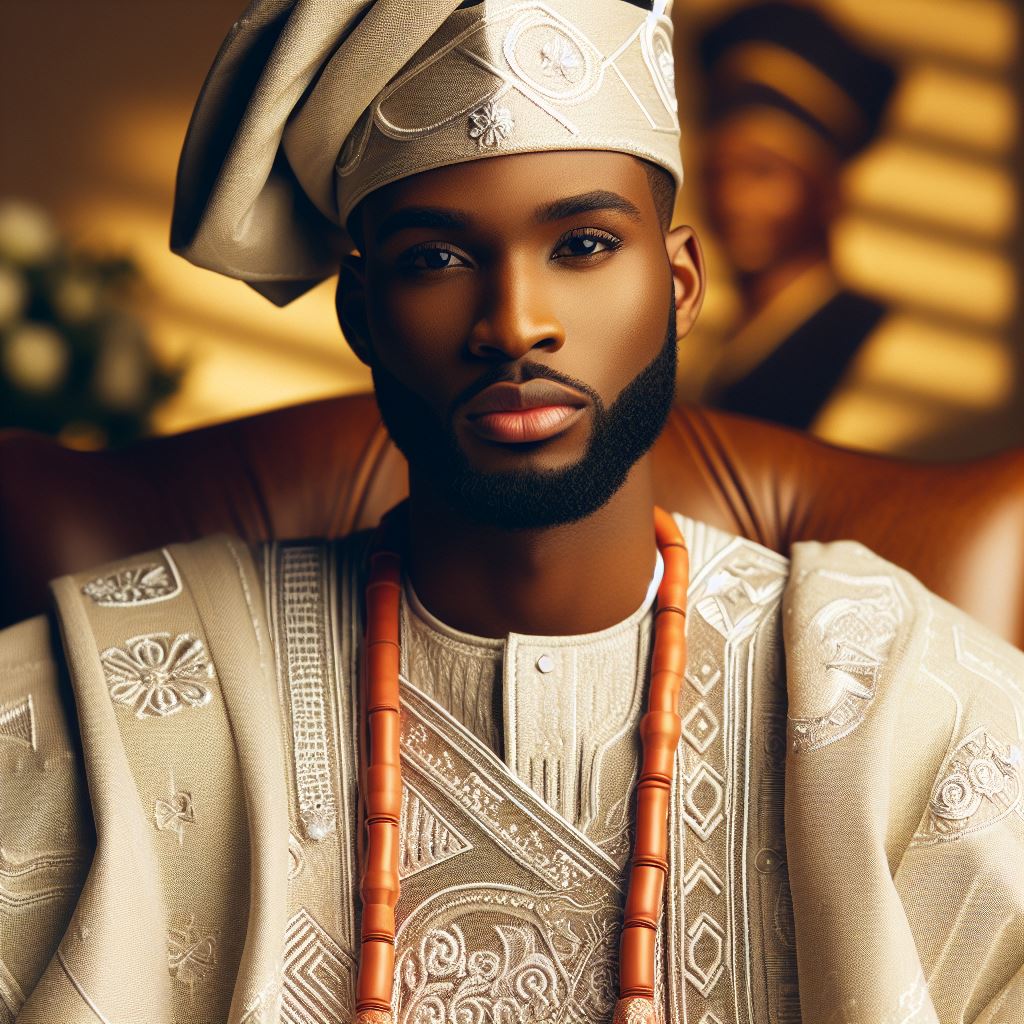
[279,545,338,842]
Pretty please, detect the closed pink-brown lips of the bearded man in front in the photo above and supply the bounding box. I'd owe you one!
[465,380,588,444]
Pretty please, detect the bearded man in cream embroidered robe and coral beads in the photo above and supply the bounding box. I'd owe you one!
[0,0,1024,1024]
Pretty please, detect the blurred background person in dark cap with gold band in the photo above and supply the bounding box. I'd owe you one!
[689,0,895,430]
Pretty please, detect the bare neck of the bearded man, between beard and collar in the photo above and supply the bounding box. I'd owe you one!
[406,456,656,637]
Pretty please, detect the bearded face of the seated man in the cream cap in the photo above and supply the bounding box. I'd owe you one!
[352,152,676,528]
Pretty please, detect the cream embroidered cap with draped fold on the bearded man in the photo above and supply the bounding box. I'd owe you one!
[171,0,683,305]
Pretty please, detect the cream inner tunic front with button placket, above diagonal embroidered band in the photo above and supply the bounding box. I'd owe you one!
[400,552,664,865]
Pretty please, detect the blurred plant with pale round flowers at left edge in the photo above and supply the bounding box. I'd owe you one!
[0,200,182,447]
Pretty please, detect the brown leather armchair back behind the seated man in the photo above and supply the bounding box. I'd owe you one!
[0,395,1024,646]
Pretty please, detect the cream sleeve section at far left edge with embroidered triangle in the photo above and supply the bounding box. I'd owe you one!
[0,615,95,1022]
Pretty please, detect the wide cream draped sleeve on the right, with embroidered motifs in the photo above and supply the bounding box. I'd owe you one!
[783,542,1024,1024]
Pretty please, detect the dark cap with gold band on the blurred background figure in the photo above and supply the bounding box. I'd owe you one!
[700,2,896,157]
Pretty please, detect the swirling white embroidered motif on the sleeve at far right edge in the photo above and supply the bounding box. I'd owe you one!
[913,728,1024,846]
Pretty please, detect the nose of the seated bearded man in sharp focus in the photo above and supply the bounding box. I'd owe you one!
[469,263,565,359]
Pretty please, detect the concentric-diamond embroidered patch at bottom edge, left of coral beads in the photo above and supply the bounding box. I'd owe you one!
[281,907,355,1024]
